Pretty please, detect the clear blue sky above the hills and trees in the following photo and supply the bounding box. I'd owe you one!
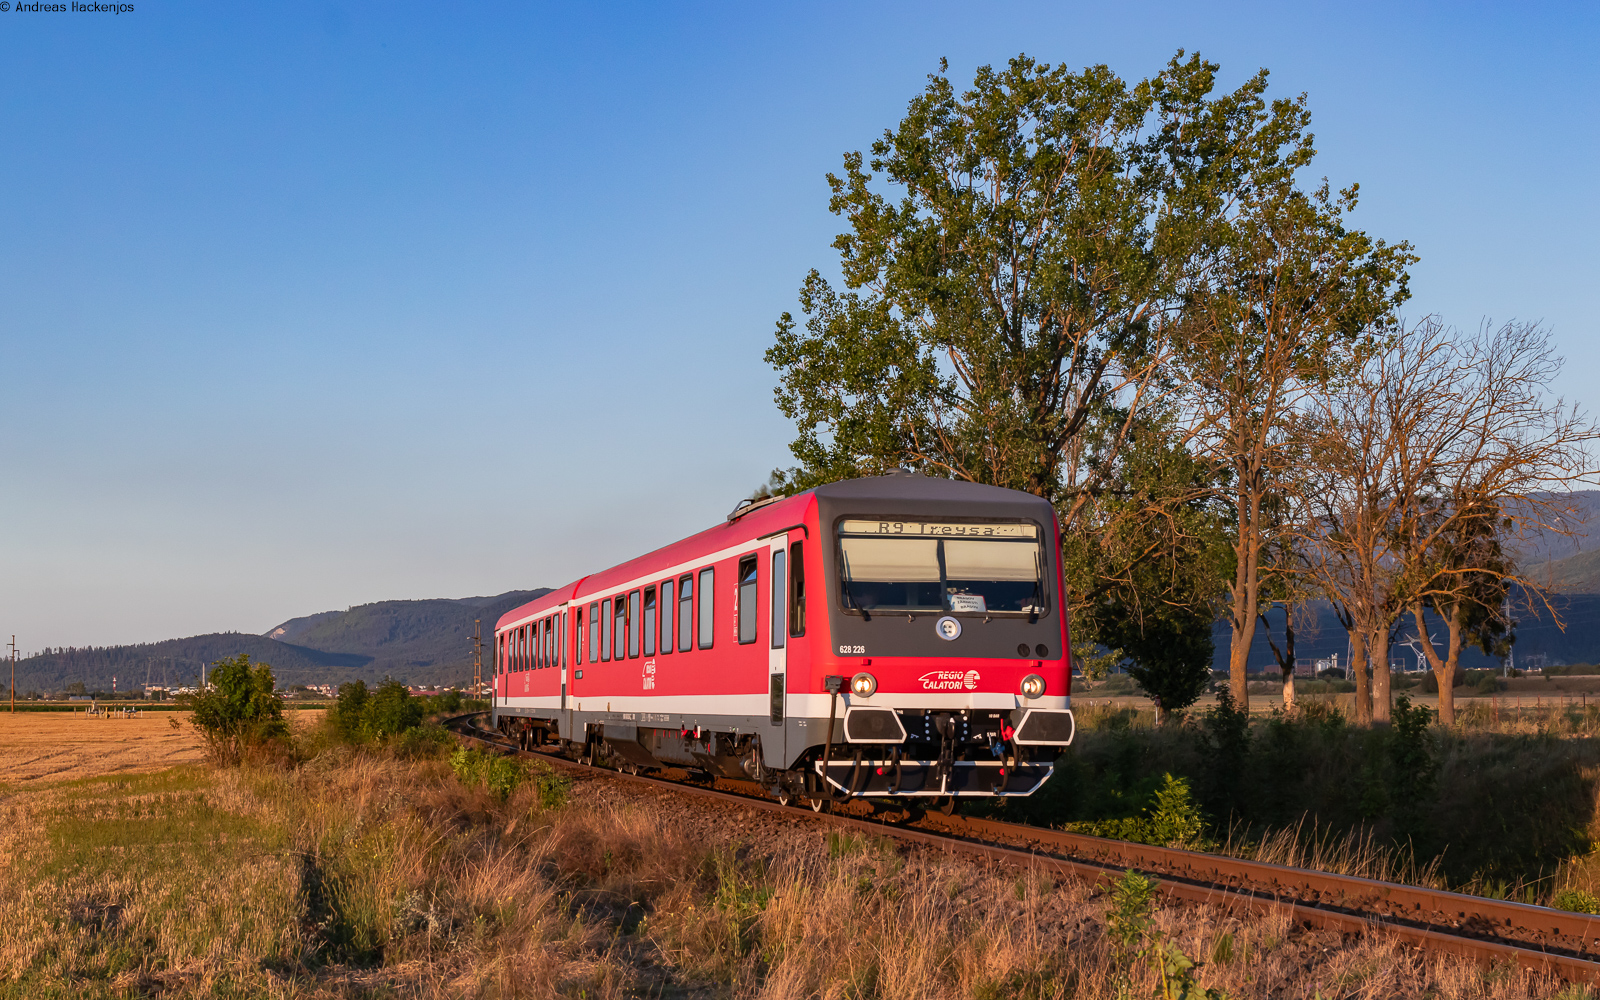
[0,0,1600,651]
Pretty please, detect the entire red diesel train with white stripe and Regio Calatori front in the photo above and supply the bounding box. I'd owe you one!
[494,472,1074,805]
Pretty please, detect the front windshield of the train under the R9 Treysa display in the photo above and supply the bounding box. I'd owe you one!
[838,520,1045,614]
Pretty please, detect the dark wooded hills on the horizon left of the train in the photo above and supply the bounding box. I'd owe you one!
[0,589,549,693]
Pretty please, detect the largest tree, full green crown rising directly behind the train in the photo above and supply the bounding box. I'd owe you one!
[766,53,1306,681]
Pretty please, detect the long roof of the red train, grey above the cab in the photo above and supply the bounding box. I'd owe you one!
[494,470,1054,630]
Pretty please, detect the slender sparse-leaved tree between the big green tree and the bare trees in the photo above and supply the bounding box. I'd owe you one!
[1178,174,1416,707]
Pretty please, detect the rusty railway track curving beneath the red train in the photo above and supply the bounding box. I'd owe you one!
[446,715,1600,984]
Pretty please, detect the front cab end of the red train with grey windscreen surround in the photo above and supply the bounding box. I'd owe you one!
[784,474,1074,802]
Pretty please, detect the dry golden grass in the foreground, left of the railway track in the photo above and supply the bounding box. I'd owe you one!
[0,749,1578,1000]
